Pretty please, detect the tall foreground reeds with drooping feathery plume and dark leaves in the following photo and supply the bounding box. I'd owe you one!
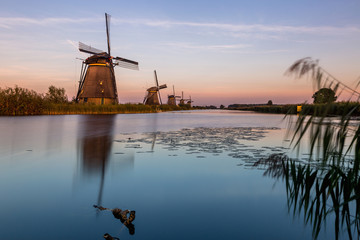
[268,58,360,239]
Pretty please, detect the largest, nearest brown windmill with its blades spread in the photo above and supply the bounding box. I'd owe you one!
[76,13,139,104]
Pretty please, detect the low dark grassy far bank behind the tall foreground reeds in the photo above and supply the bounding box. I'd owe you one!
[229,102,360,116]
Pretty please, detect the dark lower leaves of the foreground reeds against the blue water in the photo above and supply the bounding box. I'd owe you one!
[254,155,360,239]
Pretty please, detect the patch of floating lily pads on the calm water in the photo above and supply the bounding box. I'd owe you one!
[114,127,288,164]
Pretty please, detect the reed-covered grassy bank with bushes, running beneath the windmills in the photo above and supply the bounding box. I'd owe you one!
[0,86,191,116]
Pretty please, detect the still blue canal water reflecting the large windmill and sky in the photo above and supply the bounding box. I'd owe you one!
[0,110,340,239]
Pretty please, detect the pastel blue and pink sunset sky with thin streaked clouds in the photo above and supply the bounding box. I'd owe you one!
[0,0,360,106]
